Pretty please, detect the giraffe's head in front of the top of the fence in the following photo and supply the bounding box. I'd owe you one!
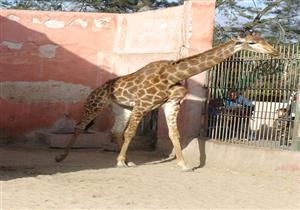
[235,33,279,56]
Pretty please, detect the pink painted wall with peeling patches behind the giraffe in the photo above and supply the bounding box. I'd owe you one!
[0,0,214,142]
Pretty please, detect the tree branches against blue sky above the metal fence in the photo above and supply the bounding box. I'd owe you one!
[215,0,300,44]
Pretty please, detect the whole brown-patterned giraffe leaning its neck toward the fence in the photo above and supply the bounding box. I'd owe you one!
[55,33,278,171]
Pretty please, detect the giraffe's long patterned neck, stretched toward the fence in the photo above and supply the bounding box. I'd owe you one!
[171,40,239,83]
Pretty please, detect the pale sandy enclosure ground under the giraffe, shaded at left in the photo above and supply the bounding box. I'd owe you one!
[0,146,300,209]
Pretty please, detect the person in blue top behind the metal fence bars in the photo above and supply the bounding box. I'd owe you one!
[225,89,256,140]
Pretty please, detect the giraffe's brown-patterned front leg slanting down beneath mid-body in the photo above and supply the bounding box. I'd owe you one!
[117,109,143,167]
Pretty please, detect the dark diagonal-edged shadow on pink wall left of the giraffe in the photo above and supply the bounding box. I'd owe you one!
[0,16,117,138]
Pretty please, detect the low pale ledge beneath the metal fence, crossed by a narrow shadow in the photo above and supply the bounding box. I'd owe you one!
[159,138,300,172]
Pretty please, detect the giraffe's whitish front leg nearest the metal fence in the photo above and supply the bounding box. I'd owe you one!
[163,100,192,171]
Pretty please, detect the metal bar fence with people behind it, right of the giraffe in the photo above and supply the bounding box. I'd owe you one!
[207,43,300,149]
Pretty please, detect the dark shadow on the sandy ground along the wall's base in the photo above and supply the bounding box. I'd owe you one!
[0,145,163,181]
